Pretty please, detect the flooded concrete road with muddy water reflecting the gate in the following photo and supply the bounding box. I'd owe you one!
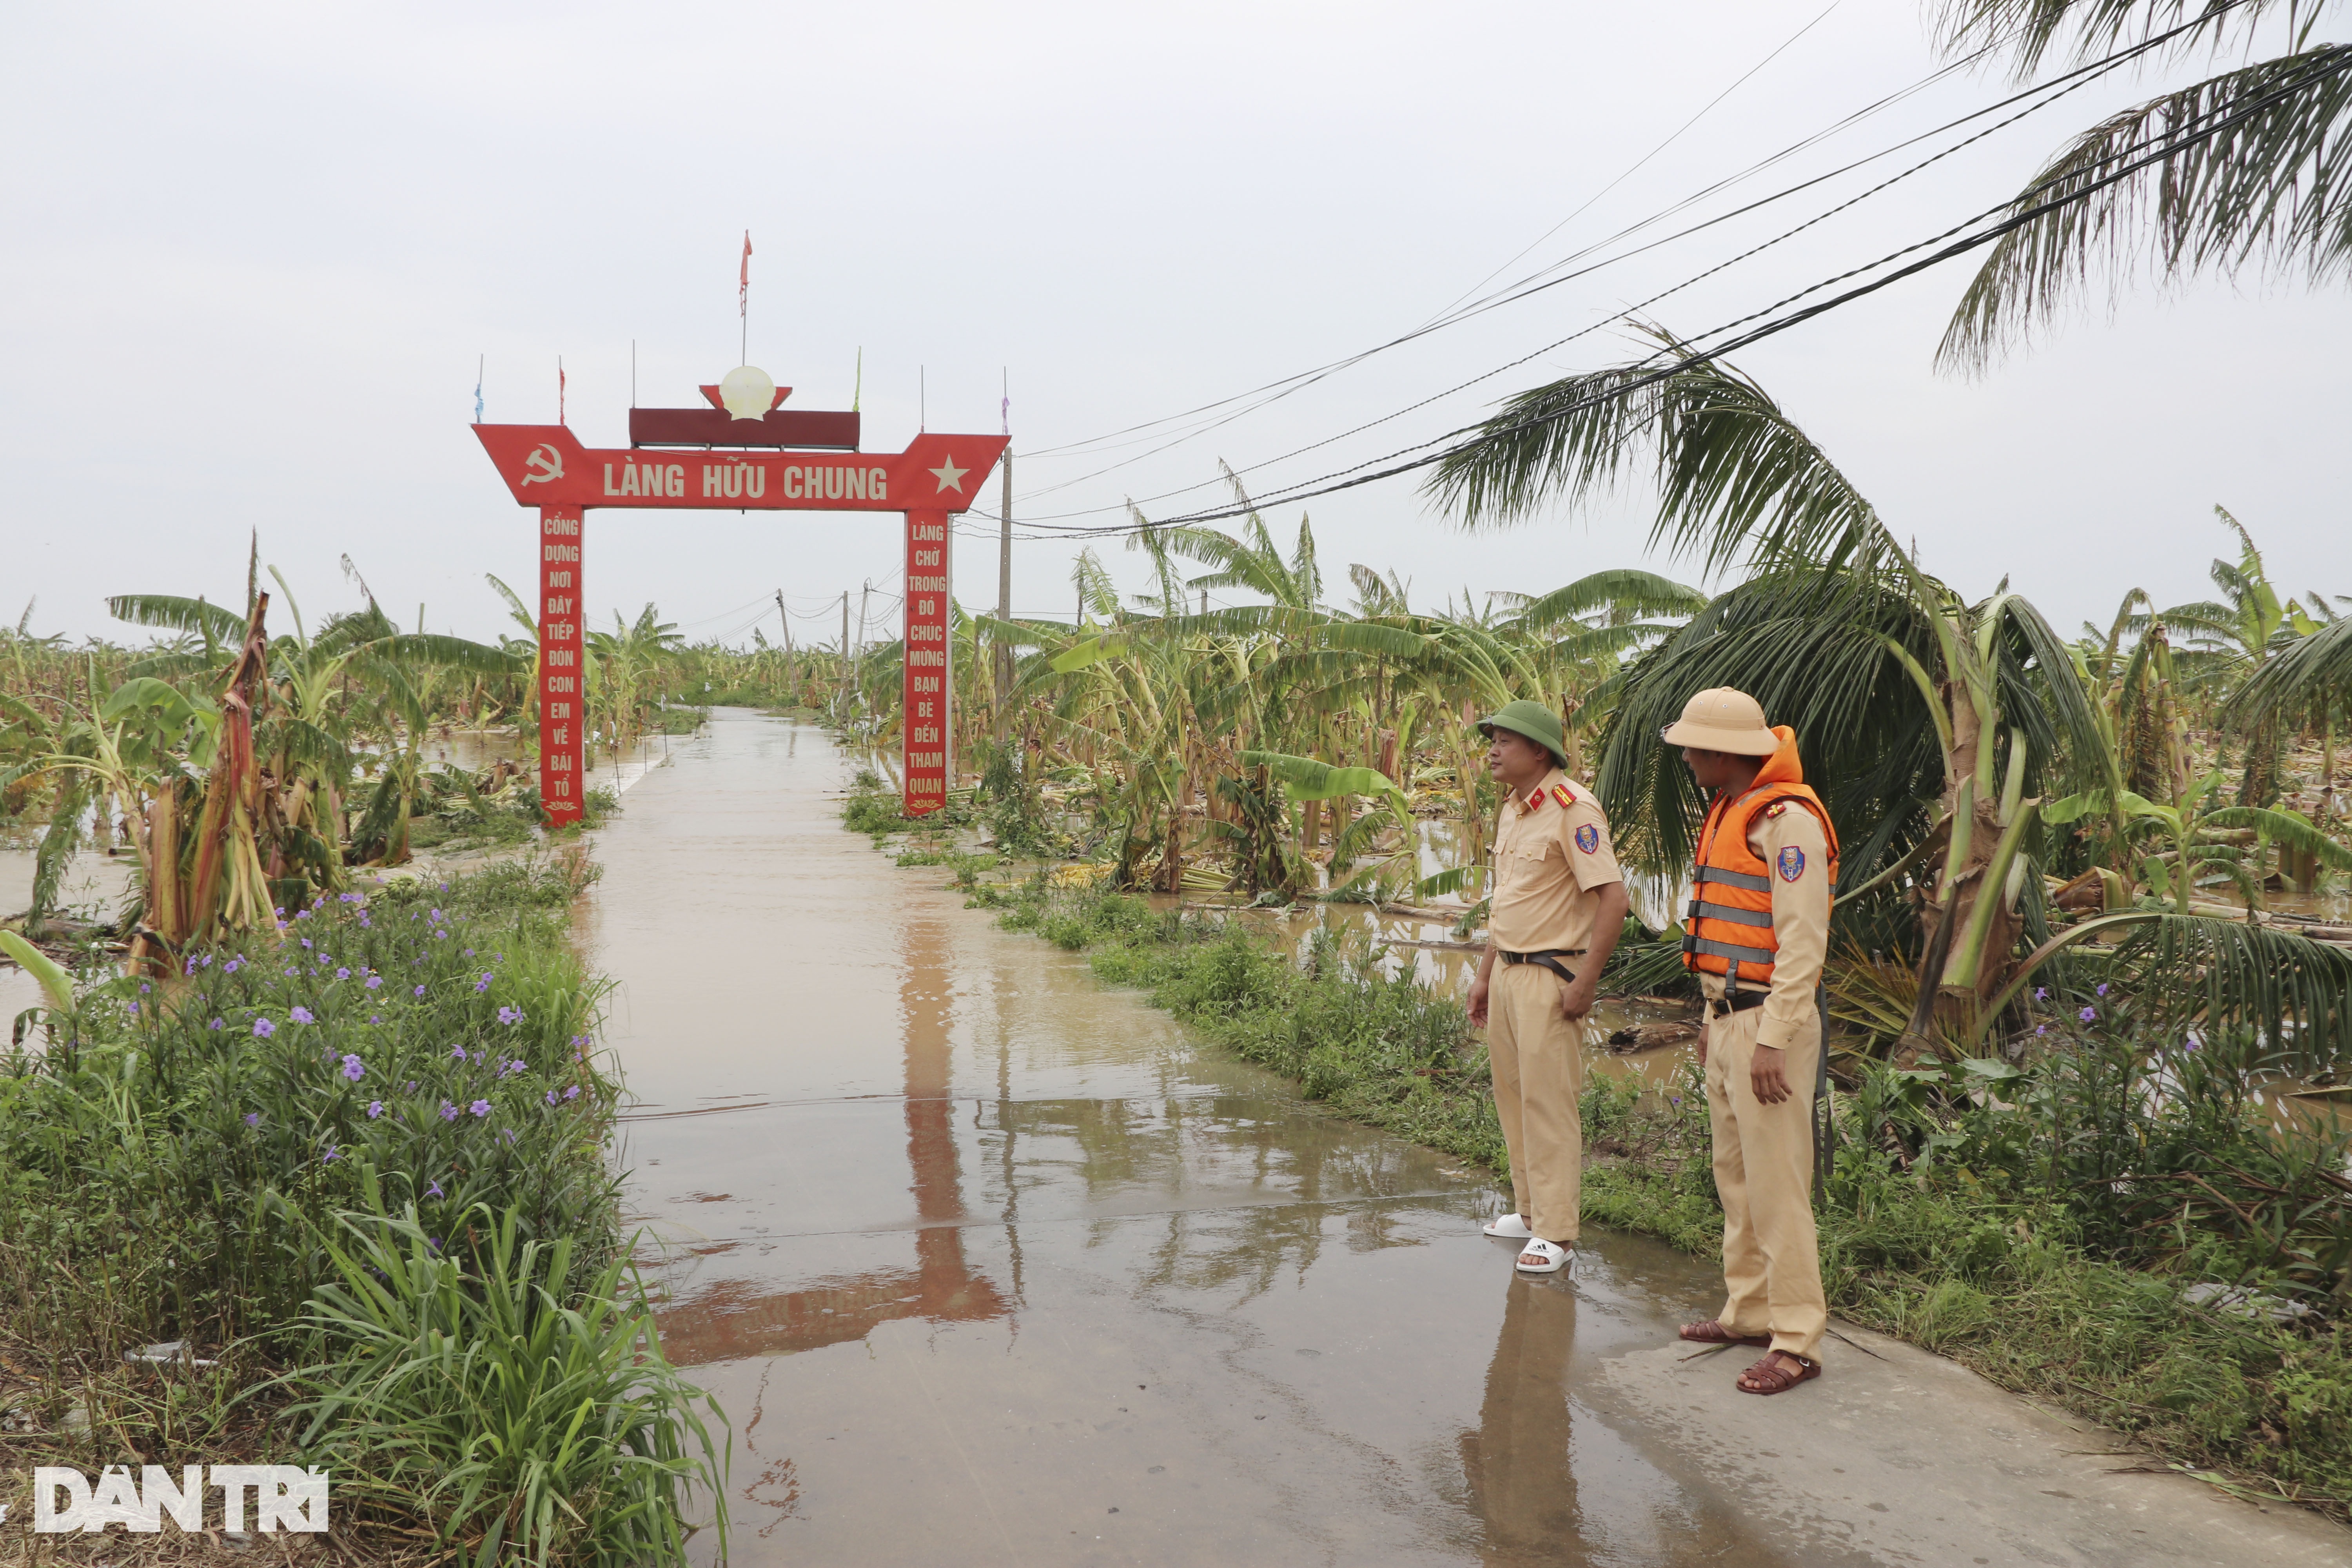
[581,710,2345,1566]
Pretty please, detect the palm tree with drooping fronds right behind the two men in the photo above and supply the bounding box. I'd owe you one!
[1428,332,2352,1060]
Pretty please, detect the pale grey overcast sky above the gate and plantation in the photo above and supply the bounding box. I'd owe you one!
[0,0,2352,642]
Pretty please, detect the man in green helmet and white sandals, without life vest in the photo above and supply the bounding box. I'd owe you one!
[1470,701,1625,1274]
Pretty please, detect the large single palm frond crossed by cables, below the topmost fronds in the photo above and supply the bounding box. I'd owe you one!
[1936,45,2352,372]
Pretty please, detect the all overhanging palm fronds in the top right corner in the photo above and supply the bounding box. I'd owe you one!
[1933,0,2352,369]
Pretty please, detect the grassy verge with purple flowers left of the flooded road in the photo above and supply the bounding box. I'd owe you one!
[0,851,724,1563]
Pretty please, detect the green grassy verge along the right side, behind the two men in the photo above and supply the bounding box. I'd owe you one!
[941,867,2352,1519]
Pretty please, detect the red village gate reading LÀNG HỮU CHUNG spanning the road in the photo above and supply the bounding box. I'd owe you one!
[473,367,1007,825]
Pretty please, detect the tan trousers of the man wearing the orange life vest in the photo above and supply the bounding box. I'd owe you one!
[1708,1009,1830,1361]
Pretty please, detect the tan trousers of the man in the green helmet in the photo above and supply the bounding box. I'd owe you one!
[1486,964,1585,1241]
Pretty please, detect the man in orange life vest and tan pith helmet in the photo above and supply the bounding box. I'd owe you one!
[1665,686,1837,1394]
